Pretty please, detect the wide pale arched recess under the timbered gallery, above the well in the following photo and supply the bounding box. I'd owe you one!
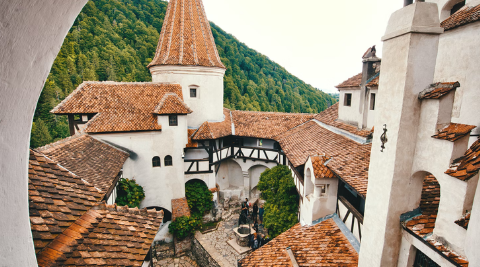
[216,159,244,191]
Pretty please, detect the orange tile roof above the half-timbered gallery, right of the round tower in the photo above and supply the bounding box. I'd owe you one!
[232,110,315,139]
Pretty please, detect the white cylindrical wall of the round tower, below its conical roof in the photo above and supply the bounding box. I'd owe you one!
[150,66,225,127]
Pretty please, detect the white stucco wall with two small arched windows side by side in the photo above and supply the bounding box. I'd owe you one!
[92,116,187,214]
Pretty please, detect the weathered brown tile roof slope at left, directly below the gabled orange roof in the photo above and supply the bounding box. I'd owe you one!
[38,134,129,193]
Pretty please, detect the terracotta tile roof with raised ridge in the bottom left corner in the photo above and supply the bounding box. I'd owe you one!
[37,204,163,267]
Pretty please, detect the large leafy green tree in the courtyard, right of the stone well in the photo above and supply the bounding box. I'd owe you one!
[257,165,299,237]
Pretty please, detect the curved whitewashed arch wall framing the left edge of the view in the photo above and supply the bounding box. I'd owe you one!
[0,0,87,266]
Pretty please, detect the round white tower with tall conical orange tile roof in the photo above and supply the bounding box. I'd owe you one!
[148,0,225,127]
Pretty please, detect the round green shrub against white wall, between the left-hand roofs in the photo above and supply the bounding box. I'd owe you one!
[115,178,145,208]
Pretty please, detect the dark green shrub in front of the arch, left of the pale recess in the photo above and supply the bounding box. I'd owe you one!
[185,180,213,218]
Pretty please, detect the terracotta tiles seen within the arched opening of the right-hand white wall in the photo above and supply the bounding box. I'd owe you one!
[405,174,440,238]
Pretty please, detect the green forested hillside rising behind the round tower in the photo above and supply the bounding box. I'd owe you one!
[31,0,335,147]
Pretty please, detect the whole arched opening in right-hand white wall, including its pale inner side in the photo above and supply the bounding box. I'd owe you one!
[405,174,440,237]
